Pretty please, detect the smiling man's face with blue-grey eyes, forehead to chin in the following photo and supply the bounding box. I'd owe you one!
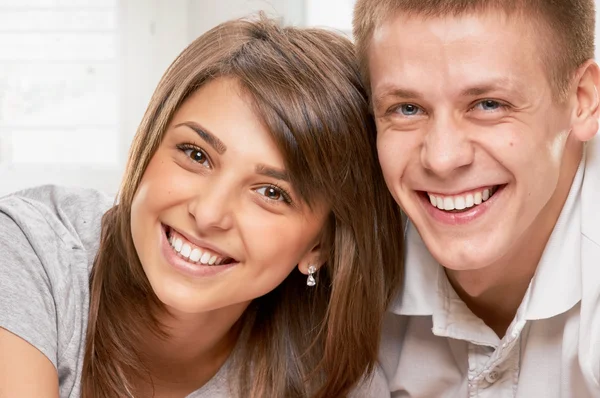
[368,13,577,270]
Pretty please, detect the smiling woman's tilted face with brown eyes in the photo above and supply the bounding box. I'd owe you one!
[131,78,330,314]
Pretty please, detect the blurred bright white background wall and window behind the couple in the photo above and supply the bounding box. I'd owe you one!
[0,0,600,195]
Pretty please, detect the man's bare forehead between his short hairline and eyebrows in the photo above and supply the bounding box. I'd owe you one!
[368,11,543,101]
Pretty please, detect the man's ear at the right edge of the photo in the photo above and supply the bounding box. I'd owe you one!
[571,60,600,142]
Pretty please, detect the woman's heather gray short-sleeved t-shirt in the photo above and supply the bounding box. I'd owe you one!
[0,186,229,398]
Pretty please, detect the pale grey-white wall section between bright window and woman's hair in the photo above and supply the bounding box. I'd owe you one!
[120,0,305,159]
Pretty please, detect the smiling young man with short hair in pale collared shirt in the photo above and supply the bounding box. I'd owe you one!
[354,0,600,398]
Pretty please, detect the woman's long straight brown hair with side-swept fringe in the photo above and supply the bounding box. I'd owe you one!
[82,16,402,398]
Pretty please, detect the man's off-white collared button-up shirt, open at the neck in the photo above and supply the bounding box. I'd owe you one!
[380,148,600,398]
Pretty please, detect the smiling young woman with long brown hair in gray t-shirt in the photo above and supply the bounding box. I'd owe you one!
[0,14,402,398]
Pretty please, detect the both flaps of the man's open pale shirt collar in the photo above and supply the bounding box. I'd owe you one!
[390,156,585,319]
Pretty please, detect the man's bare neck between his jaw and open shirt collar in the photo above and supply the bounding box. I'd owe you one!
[446,141,583,337]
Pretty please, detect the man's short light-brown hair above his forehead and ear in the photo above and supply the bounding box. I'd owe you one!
[353,0,596,99]
